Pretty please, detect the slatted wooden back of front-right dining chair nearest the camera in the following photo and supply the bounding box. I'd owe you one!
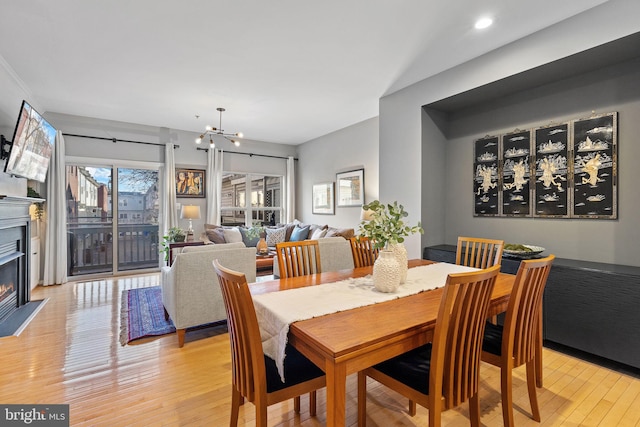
[429,265,500,413]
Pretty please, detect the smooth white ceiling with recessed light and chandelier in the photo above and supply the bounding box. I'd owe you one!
[0,0,605,144]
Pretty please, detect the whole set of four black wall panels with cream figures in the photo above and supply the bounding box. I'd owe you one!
[473,112,618,219]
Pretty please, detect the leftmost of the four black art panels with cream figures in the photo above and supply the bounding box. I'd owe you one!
[473,135,502,216]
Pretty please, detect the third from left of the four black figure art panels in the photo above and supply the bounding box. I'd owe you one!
[533,123,571,218]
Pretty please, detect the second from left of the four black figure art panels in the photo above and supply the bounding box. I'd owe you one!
[501,129,531,216]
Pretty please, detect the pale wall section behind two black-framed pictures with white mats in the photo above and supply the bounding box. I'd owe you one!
[296,117,378,230]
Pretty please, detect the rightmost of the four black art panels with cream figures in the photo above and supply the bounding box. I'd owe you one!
[571,113,618,219]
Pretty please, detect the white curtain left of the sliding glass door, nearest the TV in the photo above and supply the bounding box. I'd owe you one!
[42,131,67,286]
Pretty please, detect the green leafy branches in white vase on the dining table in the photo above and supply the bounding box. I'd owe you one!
[359,200,424,289]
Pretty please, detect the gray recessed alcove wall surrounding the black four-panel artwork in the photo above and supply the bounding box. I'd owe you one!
[444,58,640,266]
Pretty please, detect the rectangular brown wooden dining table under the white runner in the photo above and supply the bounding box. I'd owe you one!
[250,259,515,426]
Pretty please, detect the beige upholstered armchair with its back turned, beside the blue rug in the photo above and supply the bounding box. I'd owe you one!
[160,243,256,347]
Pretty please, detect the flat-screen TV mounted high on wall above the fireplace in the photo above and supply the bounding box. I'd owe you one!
[4,101,56,182]
